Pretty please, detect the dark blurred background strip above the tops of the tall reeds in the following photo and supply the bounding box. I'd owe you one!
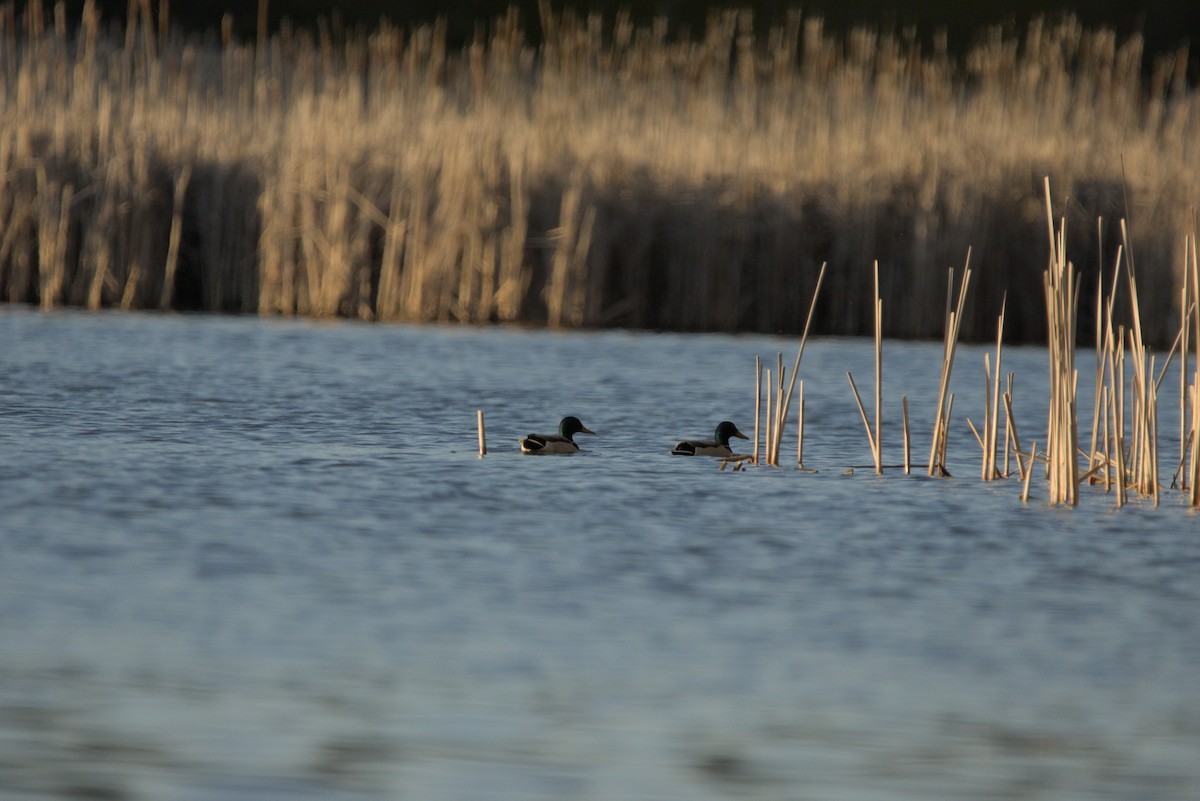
[56,0,1200,62]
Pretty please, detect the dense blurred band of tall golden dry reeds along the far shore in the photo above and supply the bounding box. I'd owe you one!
[0,2,1200,343]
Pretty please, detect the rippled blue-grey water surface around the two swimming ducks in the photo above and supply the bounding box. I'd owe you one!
[0,308,1200,801]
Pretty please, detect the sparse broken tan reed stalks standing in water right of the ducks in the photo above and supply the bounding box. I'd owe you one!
[752,179,1200,507]
